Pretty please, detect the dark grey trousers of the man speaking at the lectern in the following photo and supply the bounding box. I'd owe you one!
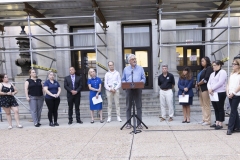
[126,89,142,125]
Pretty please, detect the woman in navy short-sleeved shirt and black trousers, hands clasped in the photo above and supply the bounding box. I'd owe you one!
[44,70,61,127]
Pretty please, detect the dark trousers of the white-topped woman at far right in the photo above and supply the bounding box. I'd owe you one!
[228,96,240,131]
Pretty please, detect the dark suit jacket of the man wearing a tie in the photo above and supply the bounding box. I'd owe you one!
[64,75,82,97]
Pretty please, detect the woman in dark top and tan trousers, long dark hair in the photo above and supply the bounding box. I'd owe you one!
[196,57,213,126]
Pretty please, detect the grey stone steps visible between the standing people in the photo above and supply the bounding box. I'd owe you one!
[3,90,204,119]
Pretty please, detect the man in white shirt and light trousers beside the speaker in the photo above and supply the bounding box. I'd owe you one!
[104,61,122,123]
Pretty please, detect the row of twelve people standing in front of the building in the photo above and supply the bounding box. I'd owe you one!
[0,54,240,135]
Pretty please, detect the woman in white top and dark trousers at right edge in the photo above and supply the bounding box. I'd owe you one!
[227,59,240,135]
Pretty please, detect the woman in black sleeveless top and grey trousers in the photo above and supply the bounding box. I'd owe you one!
[24,69,44,127]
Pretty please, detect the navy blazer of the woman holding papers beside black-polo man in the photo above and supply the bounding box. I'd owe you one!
[178,78,194,97]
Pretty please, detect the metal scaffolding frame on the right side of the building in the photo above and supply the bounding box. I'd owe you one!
[158,6,240,75]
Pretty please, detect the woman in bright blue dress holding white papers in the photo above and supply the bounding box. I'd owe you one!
[88,68,104,123]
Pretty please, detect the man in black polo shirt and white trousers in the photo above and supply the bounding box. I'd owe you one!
[158,64,175,122]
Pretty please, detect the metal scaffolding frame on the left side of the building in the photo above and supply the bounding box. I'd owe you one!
[0,10,108,114]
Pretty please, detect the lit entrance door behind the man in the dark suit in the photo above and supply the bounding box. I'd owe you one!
[72,50,96,91]
